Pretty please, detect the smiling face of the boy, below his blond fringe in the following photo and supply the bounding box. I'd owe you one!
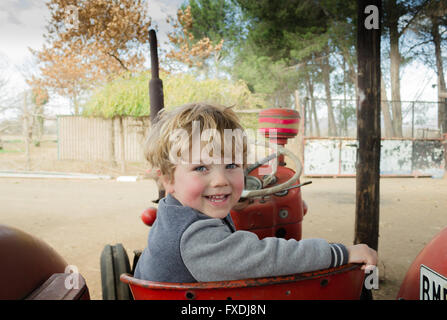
[163,161,244,219]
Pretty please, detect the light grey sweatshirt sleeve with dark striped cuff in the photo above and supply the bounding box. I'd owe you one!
[180,219,348,281]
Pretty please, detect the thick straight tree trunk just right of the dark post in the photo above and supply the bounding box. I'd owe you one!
[390,16,403,138]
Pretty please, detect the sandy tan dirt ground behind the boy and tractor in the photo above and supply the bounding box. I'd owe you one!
[0,138,447,299]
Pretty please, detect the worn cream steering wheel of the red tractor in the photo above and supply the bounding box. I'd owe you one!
[241,145,303,198]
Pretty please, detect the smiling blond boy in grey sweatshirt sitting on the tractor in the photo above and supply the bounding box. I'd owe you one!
[134,104,377,282]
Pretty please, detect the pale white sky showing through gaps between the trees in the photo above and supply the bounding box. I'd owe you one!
[0,0,437,119]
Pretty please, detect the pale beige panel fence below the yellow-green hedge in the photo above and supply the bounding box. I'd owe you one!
[57,116,150,162]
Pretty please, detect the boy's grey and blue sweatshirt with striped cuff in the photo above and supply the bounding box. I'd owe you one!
[134,194,348,282]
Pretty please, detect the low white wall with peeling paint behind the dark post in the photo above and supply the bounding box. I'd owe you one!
[303,138,445,177]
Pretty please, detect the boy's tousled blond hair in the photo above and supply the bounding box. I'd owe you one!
[145,103,247,180]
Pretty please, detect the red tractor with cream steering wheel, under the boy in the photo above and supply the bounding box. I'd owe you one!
[101,109,364,299]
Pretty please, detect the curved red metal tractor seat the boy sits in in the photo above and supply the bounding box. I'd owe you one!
[120,264,364,300]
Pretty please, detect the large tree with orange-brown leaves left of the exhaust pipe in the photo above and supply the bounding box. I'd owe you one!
[29,0,151,114]
